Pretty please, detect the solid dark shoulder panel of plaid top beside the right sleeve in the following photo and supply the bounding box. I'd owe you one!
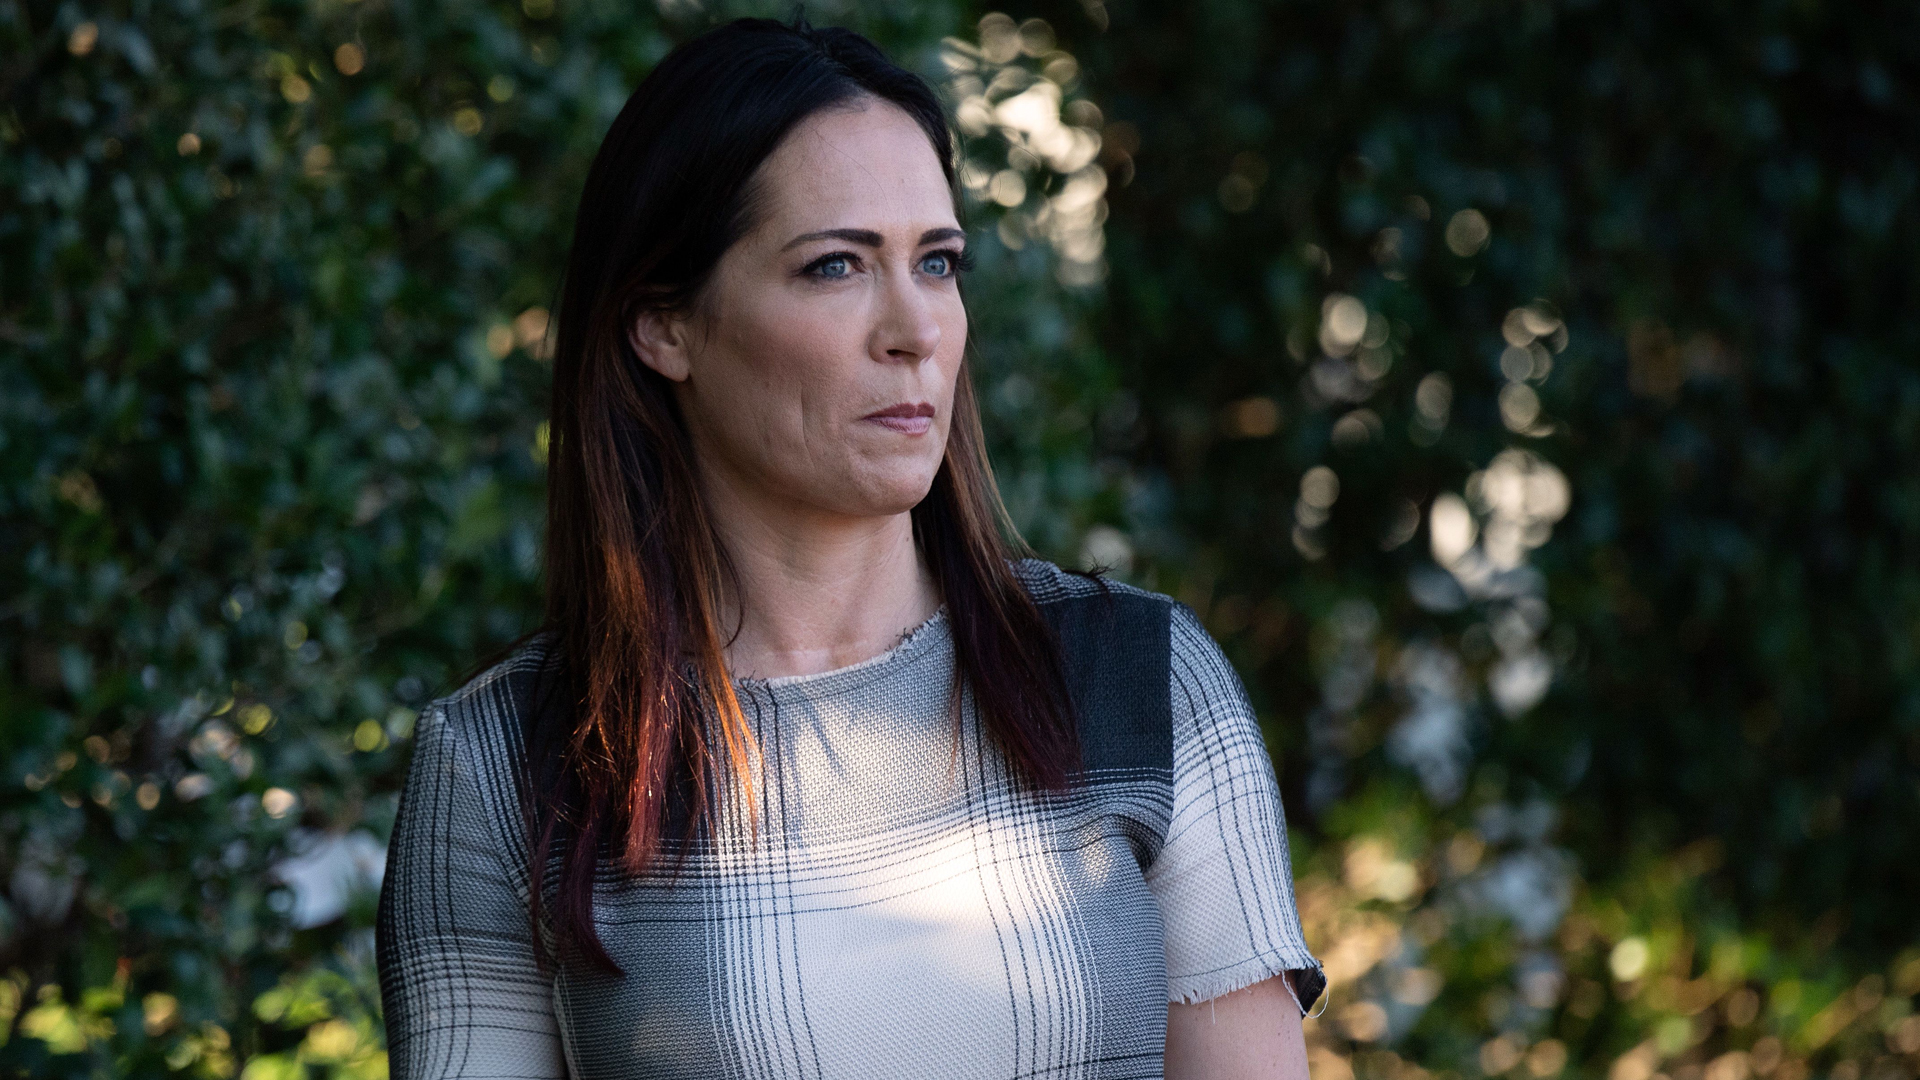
[1021,559,1173,776]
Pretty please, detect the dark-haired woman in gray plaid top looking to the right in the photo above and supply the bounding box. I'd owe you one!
[380,10,1325,1080]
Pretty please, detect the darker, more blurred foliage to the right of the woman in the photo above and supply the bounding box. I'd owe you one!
[1031,0,1920,1080]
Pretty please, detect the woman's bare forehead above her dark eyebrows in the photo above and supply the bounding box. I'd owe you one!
[758,100,956,233]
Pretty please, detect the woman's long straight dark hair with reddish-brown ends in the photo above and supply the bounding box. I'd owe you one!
[526,15,1079,970]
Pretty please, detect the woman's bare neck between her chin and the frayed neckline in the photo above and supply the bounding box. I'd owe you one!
[705,463,941,678]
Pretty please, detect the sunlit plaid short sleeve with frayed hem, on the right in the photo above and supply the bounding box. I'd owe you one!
[1146,603,1327,1007]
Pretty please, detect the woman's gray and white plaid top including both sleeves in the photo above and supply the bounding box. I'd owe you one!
[378,561,1325,1080]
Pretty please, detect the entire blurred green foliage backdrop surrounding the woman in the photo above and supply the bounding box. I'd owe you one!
[0,0,1920,1080]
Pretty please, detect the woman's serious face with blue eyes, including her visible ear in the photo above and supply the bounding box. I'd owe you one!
[634,98,968,517]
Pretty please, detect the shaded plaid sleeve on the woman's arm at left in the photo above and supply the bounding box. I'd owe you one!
[376,703,566,1080]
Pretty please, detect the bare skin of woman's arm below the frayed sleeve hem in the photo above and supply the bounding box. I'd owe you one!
[1165,974,1308,1080]
